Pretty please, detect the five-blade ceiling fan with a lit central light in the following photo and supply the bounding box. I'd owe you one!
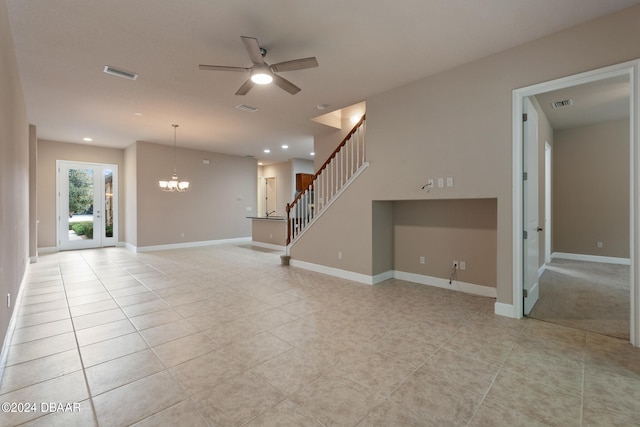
[199,36,318,95]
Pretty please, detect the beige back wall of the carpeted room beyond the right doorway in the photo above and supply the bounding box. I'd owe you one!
[552,120,630,258]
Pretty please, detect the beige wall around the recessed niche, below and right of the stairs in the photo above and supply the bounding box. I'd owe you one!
[291,7,640,304]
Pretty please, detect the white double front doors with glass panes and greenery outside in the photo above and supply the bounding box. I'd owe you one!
[57,160,118,250]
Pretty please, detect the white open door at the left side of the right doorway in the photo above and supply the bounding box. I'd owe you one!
[522,98,542,316]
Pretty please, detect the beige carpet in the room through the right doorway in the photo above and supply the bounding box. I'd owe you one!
[529,259,630,340]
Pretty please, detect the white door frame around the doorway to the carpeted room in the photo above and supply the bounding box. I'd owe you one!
[510,60,640,347]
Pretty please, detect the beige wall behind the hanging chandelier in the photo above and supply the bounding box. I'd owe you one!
[135,141,258,248]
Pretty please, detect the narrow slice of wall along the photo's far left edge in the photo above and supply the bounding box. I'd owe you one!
[0,2,29,348]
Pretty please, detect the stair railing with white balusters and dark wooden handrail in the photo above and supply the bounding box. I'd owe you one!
[287,116,369,248]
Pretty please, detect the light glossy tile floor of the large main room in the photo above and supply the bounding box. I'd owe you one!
[0,246,640,427]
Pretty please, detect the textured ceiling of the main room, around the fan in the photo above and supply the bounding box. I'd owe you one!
[6,0,640,163]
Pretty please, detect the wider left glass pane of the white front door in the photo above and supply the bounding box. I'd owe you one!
[69,168,93,241]
